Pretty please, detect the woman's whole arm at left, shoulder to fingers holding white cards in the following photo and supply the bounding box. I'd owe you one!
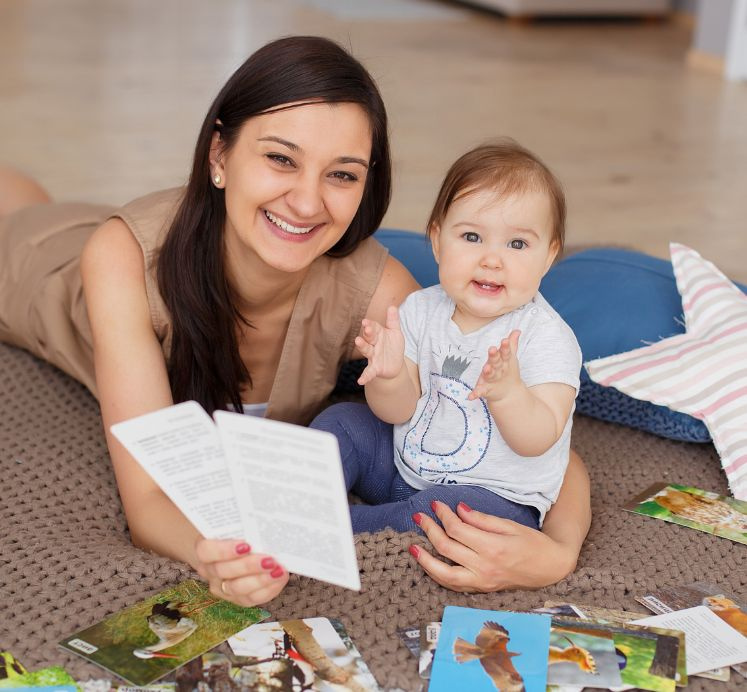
[81,219,288,605]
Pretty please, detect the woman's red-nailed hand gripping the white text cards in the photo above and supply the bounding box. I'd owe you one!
[194,538,289,607]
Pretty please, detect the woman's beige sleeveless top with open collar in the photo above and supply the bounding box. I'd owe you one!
[0,188,387,424]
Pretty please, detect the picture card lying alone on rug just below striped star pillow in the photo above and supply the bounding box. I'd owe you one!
[623,483,747,544]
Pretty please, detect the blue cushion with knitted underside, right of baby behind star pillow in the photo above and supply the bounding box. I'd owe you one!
[540,248,747,442]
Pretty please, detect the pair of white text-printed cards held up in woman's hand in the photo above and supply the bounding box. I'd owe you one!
[111,401,360,591]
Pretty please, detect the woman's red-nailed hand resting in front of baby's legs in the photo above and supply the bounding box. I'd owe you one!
[410,502,580,593]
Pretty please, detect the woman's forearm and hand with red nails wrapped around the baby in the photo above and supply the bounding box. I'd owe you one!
[411,450,591,592]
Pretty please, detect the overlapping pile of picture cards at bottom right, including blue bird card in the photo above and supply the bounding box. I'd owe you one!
[399,596,747,692]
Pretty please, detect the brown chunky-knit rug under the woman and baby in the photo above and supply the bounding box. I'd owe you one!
[0,344,747,690]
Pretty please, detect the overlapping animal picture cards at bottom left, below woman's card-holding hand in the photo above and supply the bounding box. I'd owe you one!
[57,580,379,692]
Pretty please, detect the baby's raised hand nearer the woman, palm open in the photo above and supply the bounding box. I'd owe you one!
[355,306,405,385]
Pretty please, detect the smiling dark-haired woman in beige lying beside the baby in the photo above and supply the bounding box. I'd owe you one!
[0,37,589,605]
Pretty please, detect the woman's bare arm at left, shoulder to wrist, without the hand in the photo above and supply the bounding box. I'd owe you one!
[81,219,184,564]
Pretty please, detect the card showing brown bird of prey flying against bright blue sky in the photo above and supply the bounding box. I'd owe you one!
[428,606,551,692]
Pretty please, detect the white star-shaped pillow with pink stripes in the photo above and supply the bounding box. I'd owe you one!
[585,243,747,500]
